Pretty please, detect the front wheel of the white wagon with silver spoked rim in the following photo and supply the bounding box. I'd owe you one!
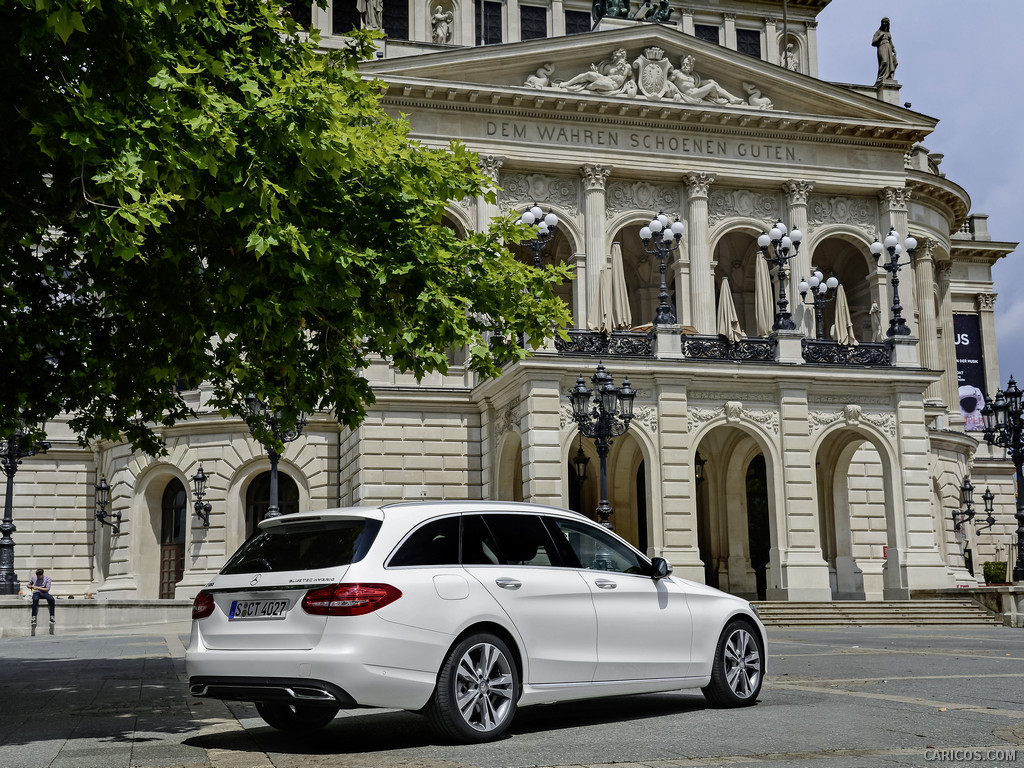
[700,621,764,707]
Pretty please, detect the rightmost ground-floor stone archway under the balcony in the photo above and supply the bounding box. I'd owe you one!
[812,421,907,600]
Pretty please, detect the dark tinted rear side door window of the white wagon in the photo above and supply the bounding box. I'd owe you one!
[463,514,561,566]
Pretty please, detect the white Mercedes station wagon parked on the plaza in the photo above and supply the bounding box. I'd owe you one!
[185,502,766,741]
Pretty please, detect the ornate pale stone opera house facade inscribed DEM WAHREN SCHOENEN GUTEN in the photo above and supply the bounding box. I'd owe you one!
[14,0,1016,600]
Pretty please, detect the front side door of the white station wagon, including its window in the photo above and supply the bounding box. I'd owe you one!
[550,517,693,681]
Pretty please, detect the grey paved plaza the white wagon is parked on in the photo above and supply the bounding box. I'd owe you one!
[0,610,1024,768]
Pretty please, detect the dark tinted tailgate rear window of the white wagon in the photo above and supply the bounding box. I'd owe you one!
[220,518,381,573]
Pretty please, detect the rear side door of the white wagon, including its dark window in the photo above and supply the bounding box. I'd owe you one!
[462,513,597,685]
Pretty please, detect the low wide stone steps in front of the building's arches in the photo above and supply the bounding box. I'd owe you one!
[754,597,1002,628]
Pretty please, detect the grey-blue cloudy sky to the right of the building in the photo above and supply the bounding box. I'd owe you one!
[818,0,1024,387]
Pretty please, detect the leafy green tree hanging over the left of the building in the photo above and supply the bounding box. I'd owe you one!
[0,0,568,453]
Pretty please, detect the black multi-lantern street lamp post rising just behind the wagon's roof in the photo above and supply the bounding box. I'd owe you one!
[568,362,636,528]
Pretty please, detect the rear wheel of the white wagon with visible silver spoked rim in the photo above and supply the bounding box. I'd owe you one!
[426,633,519,743]
